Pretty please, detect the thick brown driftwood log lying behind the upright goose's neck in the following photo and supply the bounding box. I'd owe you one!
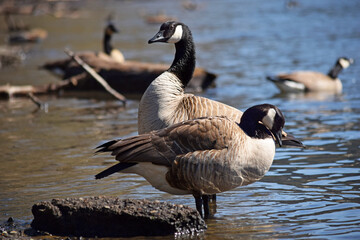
[42,52,216,95]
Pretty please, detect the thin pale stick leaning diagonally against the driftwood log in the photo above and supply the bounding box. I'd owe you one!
[64,49,126,105]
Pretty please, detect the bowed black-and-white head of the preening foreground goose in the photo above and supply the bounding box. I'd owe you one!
[240,104,285,146]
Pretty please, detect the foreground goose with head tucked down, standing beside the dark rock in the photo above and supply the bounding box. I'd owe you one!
[95,104,300,218]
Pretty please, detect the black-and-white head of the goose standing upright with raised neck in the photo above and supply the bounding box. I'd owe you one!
[148,21,185,44]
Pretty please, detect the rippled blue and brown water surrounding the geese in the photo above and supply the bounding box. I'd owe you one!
[0,0,360,239]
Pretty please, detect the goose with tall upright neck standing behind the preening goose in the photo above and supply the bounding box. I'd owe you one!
[138,21,303,214]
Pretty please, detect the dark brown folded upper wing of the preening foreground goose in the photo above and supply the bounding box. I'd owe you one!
[100,117,236,166]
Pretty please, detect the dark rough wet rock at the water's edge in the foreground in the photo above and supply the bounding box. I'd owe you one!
[31,197,206,237]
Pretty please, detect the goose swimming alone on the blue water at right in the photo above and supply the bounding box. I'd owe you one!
[266,57,354,93]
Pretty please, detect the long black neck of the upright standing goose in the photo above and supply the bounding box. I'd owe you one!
[168,31,196,88]
